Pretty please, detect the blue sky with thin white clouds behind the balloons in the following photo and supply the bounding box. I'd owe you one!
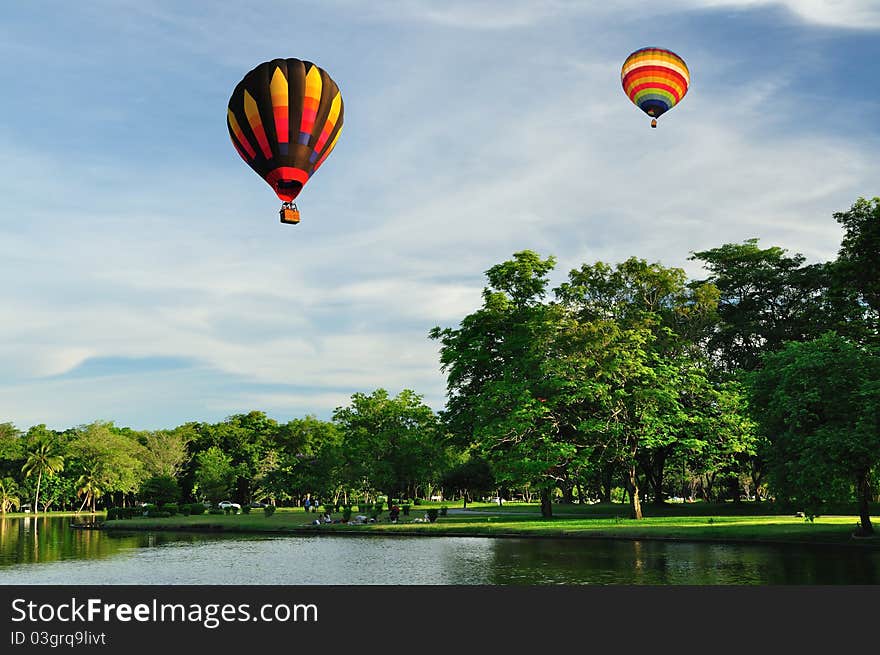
[0,0,880,429]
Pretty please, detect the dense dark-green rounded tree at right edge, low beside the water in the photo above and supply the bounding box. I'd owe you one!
[750,333,880,534]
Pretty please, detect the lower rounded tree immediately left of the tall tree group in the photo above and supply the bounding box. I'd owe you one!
[333,389,442,503]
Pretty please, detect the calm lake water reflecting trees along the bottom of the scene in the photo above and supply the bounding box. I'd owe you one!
[0,516,880,585]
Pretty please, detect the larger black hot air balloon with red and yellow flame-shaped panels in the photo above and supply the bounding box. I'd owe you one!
[226,59,343,225]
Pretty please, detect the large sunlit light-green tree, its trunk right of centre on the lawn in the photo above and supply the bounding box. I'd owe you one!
[555,257,718,518]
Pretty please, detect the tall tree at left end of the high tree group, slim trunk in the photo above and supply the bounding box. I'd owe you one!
[430,250,577,518]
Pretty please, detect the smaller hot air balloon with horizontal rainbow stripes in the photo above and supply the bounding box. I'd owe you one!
[620,48,691,127]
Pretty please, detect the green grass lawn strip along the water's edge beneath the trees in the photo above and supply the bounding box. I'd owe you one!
[104,503,880,548]
